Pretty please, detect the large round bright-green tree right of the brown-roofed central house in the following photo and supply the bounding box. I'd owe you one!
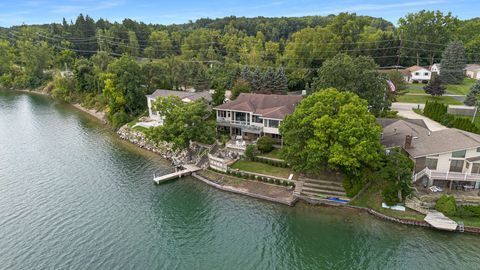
[280,88,382,178]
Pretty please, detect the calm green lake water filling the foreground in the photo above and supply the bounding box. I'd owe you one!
[0,91,480,269]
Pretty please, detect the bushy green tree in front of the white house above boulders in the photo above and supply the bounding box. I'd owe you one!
[148,96,215,149]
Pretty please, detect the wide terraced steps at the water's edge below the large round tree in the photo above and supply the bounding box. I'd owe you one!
[299,178,347,198]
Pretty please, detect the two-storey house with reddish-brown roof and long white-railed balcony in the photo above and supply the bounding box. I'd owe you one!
[214,93,302,141]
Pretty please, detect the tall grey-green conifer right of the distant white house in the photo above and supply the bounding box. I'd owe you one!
[441,41,467,84]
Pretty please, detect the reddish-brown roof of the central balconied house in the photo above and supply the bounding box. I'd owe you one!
[215,93,302,119]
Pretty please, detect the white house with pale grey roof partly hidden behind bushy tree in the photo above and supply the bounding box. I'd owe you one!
[147,89,212,125]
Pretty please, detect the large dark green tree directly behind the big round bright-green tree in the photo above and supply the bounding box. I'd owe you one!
[312,54,390,114]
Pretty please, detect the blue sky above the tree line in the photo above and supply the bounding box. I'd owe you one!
[0,0,480,26]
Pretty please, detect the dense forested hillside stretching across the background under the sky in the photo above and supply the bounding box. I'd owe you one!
[0,11,480,127]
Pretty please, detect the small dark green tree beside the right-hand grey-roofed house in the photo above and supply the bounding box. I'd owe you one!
[379,149,413,205]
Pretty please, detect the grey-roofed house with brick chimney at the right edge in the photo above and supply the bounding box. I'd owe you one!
[377,119,480,189]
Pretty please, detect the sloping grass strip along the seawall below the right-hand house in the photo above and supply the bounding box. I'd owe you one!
[349,180,425,220]
